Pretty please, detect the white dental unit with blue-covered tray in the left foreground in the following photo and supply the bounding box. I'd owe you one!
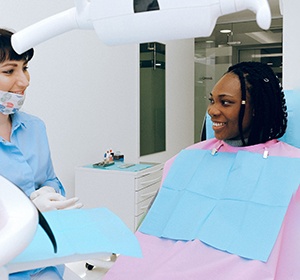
[0,176,141,280]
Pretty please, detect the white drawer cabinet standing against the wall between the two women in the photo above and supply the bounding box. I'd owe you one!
[75,164,163,231]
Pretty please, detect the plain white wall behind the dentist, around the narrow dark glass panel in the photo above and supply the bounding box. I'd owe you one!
[0,0,194,196]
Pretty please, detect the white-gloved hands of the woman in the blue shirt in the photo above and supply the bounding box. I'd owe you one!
[30,186,82,212]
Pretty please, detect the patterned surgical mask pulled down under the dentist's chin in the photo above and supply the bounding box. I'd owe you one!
[0,90,25,115]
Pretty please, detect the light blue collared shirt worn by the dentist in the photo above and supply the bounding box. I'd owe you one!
[0,112,65,279]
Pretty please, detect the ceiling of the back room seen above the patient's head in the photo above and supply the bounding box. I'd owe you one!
[195,0,282,47]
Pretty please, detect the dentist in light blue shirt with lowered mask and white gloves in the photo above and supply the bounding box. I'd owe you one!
[0,29,82,279]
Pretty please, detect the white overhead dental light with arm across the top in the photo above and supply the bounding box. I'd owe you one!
[12,0,271,53]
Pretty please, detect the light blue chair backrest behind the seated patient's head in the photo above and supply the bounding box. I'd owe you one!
[205,90,300,148]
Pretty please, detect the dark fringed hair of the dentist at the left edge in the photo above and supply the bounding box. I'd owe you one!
[0,28,34,63]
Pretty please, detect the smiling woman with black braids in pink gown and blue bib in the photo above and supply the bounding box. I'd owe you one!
[105,62,300,280]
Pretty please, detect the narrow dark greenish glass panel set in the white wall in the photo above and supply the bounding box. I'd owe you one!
[140,42,166,156]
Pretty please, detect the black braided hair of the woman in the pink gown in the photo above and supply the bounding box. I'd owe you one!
[226,61,287,146]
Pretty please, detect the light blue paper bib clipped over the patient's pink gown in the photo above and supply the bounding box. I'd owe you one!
[139,150,300,261]
